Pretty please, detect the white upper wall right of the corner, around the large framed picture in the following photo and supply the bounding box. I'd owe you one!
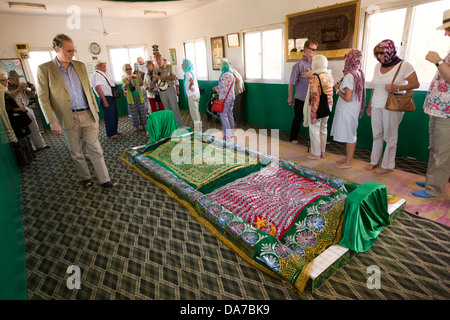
[161,0,376,83]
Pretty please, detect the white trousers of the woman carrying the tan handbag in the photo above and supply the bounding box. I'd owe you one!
[370,108,404,169]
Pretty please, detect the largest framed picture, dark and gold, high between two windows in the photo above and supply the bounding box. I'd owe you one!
[286,0,360,62]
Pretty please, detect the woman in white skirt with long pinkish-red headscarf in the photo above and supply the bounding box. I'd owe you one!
[330,49,366,169]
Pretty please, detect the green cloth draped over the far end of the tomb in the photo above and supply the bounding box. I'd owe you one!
[147,110,178,142]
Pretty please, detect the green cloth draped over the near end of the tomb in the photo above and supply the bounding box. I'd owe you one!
[339,181,390,252]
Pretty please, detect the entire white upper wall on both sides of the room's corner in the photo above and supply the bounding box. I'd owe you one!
[0,0,422,83]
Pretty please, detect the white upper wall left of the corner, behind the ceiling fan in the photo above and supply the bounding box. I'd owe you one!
[0,14,163,82]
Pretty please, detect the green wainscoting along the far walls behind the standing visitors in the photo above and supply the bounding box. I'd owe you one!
[35,79,429,162]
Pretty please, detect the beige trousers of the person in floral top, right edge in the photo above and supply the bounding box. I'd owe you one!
[424,116,450,197]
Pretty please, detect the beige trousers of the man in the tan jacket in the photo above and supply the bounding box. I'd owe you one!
[63,109,111,183]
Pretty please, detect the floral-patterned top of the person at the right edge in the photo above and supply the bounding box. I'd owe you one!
[423,52,450,118]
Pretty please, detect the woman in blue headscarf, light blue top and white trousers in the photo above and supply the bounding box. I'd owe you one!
[181,59,202,131]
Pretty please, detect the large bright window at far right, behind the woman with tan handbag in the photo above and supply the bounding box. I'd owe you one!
[363,1,450,90]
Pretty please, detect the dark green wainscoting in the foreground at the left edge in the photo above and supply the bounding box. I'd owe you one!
[0,119,27,300]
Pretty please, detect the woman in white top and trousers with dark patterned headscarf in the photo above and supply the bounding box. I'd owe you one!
[366,40,420,174]
